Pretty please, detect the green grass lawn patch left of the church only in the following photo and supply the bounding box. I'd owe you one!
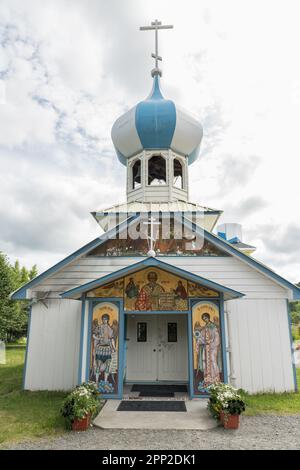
[0,345,66,446]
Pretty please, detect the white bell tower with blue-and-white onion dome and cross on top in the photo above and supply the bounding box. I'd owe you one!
[111,20,203,203]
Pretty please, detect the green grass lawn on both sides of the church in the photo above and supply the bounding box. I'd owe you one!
[0,345,300,446]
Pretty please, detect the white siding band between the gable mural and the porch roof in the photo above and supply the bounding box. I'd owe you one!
[32,256,289,299]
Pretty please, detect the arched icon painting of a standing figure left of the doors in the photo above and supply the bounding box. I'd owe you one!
[89,302,120,394]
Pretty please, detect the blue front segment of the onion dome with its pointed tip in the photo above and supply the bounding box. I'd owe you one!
[135,76,176,149]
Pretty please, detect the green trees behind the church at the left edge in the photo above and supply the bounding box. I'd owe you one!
[0,252,37,342]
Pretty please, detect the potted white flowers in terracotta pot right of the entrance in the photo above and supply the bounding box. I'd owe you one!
[208,383,245,429]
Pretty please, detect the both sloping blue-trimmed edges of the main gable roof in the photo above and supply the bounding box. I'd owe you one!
[11,214,300,300]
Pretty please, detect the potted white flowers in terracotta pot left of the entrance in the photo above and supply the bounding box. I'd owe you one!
[60,382,100,431]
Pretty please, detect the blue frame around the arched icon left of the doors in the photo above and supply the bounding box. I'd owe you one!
[85,297,124,400]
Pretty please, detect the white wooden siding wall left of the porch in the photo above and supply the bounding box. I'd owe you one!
[24,299,81,390]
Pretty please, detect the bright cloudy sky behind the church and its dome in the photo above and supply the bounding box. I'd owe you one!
[0,0,300,281]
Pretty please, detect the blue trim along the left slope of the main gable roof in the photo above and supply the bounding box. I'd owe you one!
[11,216,138,300]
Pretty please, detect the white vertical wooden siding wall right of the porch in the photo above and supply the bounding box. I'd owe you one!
[225,299,294,393]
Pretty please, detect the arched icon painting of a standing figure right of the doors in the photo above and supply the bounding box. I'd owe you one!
[192,301,224,395]
